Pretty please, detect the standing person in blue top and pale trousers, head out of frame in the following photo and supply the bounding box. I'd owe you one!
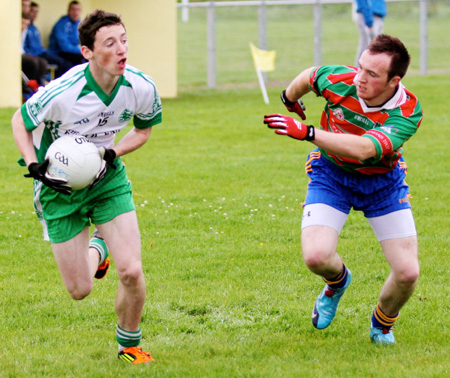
[355,0,387,66]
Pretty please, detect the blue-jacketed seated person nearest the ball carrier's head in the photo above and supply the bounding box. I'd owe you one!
[48,0,85,66]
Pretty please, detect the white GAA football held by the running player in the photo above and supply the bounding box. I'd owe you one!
[45,135,102,190]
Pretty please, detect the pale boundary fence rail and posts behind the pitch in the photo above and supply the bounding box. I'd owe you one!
[177,0,428,88]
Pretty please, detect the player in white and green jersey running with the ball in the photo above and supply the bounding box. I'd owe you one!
[12,10,161,364]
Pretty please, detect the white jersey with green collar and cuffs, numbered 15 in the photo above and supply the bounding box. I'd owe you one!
[21,63,162,162]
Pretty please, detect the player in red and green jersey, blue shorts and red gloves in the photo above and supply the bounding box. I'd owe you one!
[264,34,423,344]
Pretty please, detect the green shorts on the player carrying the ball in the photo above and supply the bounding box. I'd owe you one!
[35,158,135,243]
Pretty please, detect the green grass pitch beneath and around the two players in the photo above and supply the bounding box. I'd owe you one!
[0,76,450,377]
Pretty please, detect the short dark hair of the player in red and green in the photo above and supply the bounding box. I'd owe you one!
[367,34,411,80]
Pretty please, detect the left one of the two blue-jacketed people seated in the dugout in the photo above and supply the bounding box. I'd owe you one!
[23,2,72,78]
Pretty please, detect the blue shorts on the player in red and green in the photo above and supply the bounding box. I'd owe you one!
[305,149,411,218]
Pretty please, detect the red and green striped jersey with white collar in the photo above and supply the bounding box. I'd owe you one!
[309,66,423,175]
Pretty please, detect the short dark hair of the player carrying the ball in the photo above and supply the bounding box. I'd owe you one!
[78,9,125,50]
